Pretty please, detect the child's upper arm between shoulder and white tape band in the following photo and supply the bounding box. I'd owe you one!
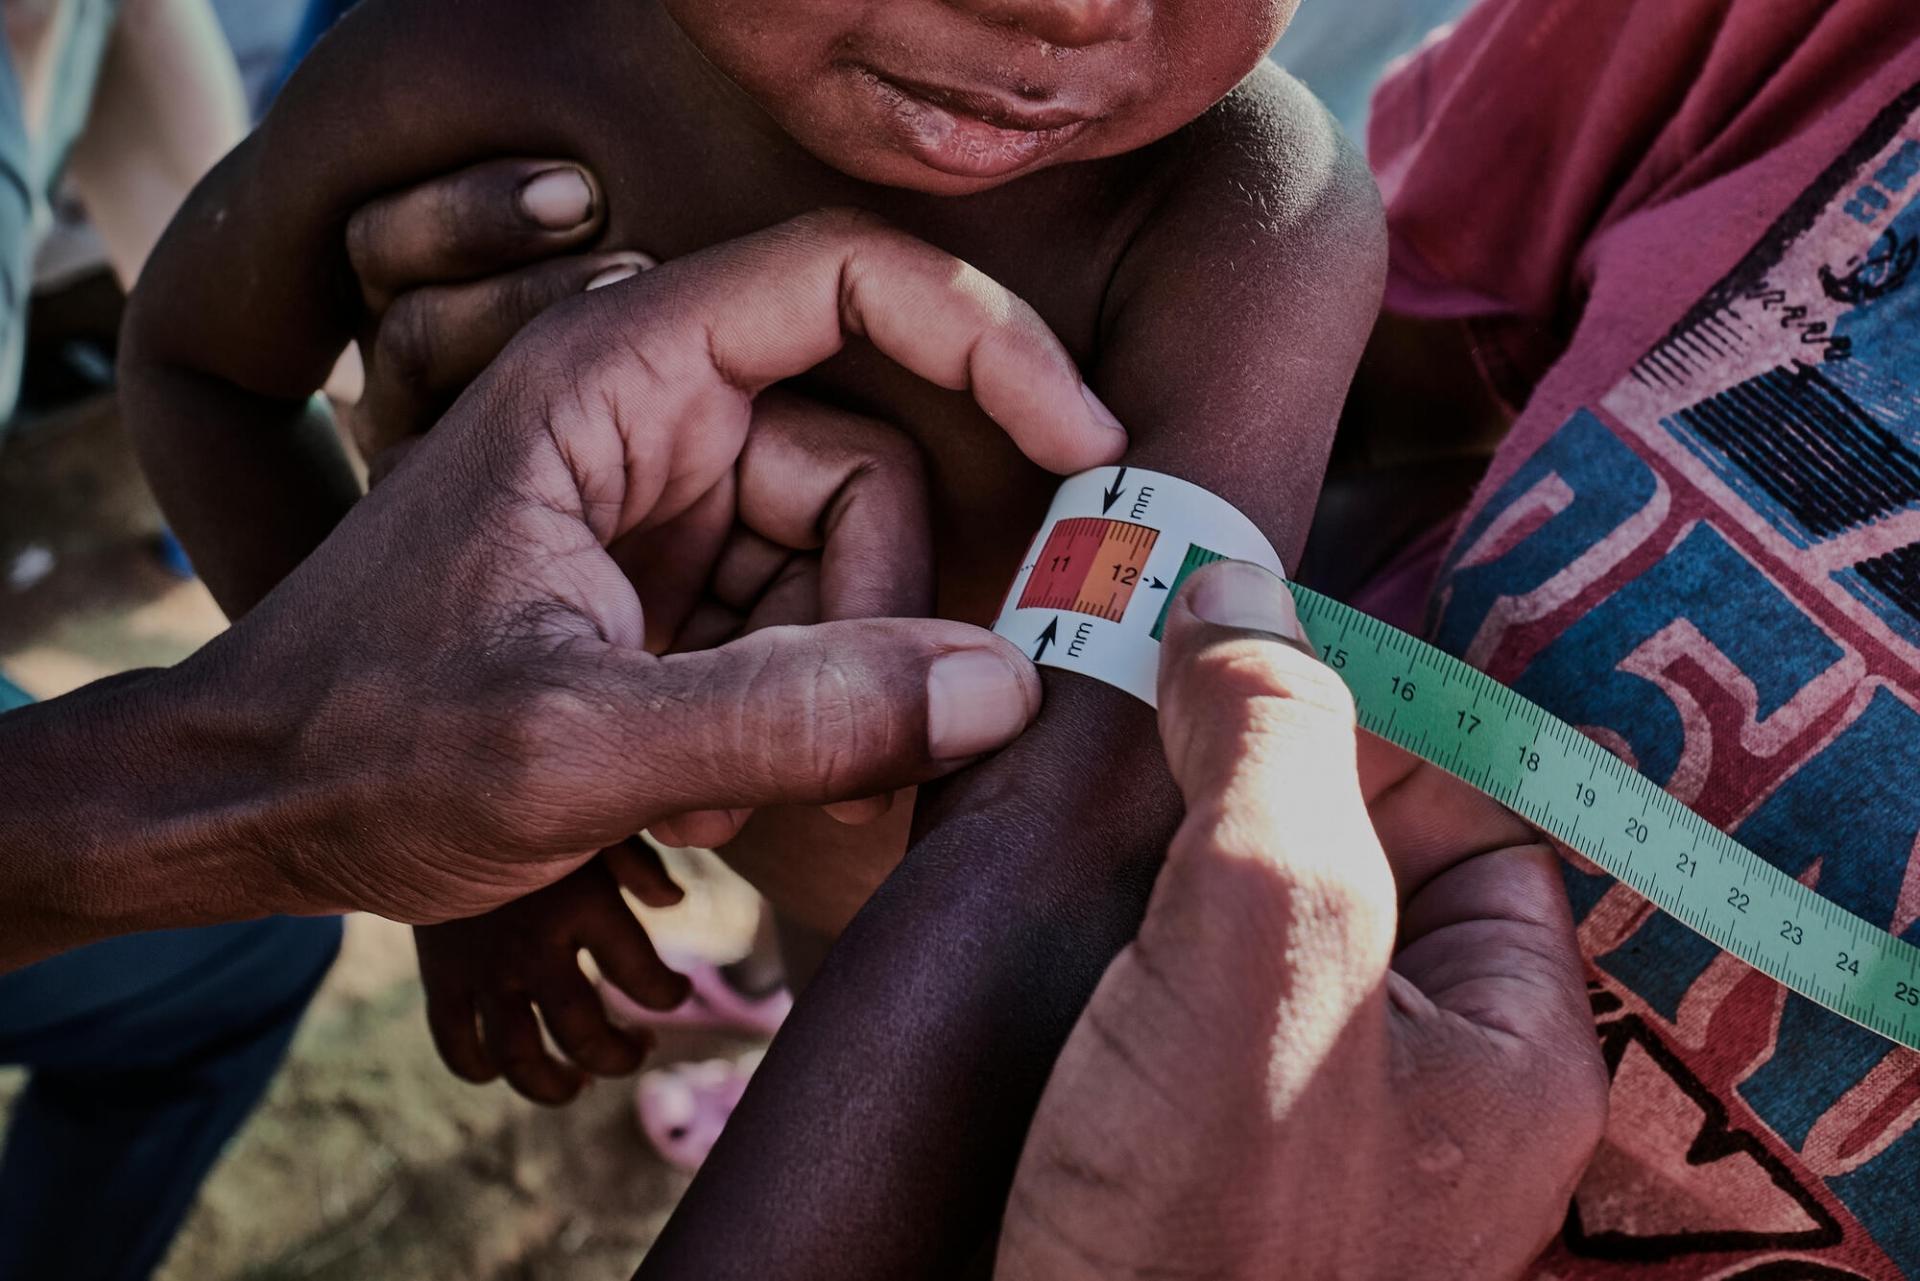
[1092,71,1386,565]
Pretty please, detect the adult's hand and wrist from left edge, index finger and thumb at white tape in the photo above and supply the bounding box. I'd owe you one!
[0,215,1123,966]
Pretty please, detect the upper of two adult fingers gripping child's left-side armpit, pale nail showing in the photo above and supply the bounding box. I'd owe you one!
[348,159,605,313]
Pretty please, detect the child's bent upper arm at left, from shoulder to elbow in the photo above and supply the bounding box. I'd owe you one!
[129,0,603,399]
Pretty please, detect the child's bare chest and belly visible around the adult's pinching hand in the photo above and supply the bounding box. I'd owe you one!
[360,4,1282,921]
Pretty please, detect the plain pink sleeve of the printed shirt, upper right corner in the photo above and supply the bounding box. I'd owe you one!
[1367,0,1920,417]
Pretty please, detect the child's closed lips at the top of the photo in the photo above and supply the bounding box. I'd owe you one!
[854,67,1092,179]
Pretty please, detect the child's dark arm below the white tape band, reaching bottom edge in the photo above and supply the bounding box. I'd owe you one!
[641,672,1181,1281]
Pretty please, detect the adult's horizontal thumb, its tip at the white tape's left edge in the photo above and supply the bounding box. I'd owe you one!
[570,618,1041,832]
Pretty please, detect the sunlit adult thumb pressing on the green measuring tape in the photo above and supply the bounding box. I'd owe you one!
[1150,561,1396,999]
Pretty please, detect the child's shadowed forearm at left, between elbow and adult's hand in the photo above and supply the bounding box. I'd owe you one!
[121,359,361,618]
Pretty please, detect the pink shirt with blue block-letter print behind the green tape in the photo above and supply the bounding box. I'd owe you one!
[1371,0,1920,1281]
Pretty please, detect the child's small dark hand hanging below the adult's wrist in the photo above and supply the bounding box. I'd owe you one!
[413,837,687,1104]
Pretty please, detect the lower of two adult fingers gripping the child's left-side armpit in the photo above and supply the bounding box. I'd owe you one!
[351,254,653,459]
